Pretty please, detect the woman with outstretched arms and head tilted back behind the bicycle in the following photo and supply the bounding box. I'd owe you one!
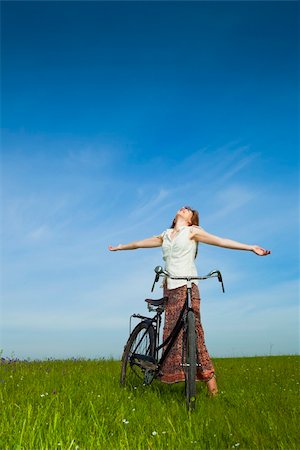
[109,206,271,395]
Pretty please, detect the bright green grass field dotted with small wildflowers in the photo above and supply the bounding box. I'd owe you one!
[0,356,300,450]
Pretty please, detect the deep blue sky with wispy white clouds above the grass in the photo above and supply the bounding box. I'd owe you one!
[0,1,299,358]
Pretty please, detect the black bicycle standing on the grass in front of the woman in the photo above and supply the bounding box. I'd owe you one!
[120,266,225,410]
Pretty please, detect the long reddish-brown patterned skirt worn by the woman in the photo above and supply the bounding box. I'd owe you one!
[160,283,215,383]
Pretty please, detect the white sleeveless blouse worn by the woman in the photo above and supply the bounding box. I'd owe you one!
[159,226,200,289]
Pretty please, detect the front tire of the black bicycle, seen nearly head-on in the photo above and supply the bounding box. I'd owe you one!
[184,311,197,410]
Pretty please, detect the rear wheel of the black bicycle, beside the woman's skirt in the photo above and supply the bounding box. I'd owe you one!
[120,322,155,385]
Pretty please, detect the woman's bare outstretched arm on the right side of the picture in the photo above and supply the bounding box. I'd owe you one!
[190,228,271,256]
